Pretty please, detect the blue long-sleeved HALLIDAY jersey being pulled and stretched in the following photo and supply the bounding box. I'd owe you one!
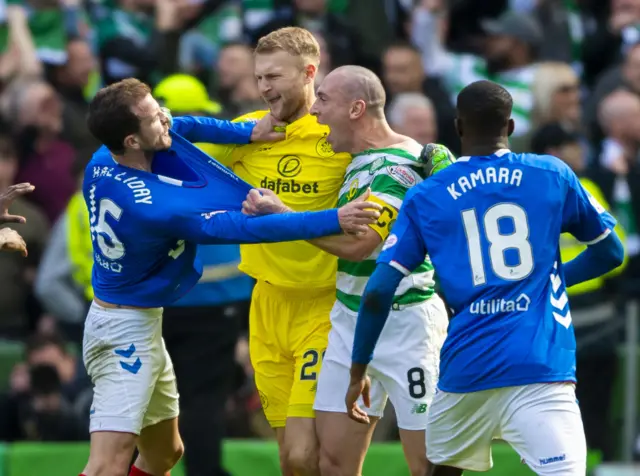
[83,116,341,307]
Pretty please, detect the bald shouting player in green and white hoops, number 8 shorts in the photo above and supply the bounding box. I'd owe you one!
[311,66,448,476]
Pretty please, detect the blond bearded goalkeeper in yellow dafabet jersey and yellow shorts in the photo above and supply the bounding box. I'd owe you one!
[203,27,351,476]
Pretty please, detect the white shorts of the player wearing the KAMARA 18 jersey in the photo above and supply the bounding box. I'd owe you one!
[427,383,587,476]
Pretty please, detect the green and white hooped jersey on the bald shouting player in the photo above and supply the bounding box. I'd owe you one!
[336,140,435,312]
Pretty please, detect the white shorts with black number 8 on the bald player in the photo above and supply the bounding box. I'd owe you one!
[313,295,449,430]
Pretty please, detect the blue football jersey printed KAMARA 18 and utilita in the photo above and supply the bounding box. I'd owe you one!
[378,150,615,393]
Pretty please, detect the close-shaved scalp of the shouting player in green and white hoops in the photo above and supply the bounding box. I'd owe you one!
[322,65,387,115]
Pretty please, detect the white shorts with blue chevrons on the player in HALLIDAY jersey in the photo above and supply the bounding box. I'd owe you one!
[82,302,179,435]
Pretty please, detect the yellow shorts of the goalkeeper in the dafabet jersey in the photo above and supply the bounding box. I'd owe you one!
[249,281,336,428]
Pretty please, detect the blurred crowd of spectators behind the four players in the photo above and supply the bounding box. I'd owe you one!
[0,0,640,474]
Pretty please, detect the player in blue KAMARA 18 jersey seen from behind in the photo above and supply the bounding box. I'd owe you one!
[351,81,624,476]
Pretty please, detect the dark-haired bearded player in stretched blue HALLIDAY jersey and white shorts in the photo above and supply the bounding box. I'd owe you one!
[83,79,380,476]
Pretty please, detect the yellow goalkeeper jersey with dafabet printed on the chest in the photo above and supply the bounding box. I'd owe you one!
[197,111,351,288]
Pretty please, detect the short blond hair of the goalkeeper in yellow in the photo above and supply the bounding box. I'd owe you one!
[254,26,320,65]
